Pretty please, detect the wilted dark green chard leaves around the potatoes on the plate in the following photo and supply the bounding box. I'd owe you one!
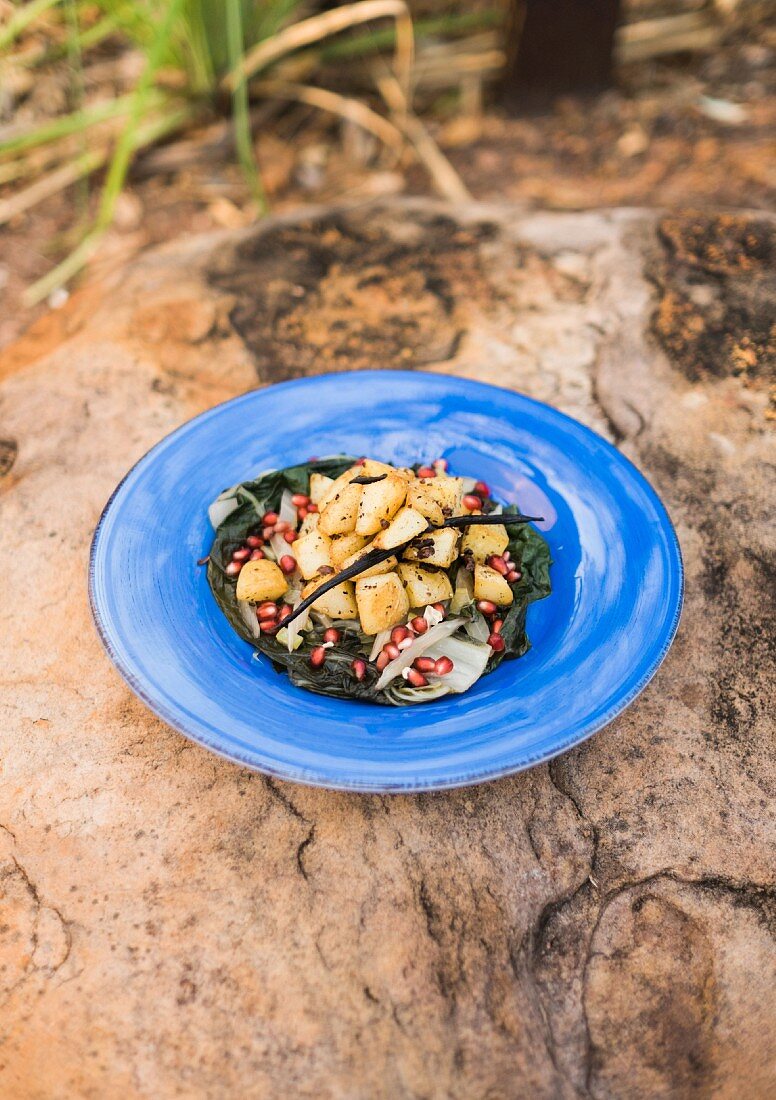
[207,455,550,706]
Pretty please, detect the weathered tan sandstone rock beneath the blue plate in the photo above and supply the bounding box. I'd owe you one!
[0,204,776,1100]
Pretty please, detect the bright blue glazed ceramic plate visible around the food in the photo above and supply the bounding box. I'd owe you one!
[90,371,682,791]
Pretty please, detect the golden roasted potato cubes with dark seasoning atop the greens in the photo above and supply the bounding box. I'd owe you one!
[238,459,513,635]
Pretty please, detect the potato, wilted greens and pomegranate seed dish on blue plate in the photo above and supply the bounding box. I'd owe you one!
[205,455,550,706]
